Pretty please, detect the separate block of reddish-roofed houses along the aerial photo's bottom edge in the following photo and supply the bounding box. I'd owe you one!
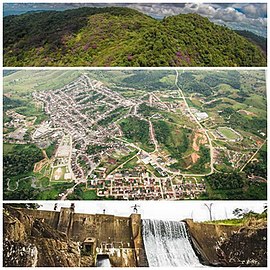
[87,172,205,200]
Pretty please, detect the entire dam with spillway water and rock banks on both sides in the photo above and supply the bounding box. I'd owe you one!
[3,206,266,267]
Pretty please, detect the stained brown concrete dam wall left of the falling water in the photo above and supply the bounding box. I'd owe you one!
[17,208,142,267]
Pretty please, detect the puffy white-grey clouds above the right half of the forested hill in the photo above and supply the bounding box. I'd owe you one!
[129,3,267,36]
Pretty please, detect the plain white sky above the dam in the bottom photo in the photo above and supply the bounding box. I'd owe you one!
[40,201,265,221]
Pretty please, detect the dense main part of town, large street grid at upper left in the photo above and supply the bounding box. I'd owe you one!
[32,75,137,180]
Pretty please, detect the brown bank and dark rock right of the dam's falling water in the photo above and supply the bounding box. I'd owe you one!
[186,220,267,266]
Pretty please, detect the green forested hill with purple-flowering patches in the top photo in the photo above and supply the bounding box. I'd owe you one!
[4,7,266,66]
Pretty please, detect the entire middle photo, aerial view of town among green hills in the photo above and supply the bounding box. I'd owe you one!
[3,69,267,200]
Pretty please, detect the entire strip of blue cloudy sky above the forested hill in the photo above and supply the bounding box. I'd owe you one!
[4,3,267,37]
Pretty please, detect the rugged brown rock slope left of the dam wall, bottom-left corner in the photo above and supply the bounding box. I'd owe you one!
[3,207,81,267]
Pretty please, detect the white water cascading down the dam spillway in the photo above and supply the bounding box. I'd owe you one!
[142,219,202,267]
